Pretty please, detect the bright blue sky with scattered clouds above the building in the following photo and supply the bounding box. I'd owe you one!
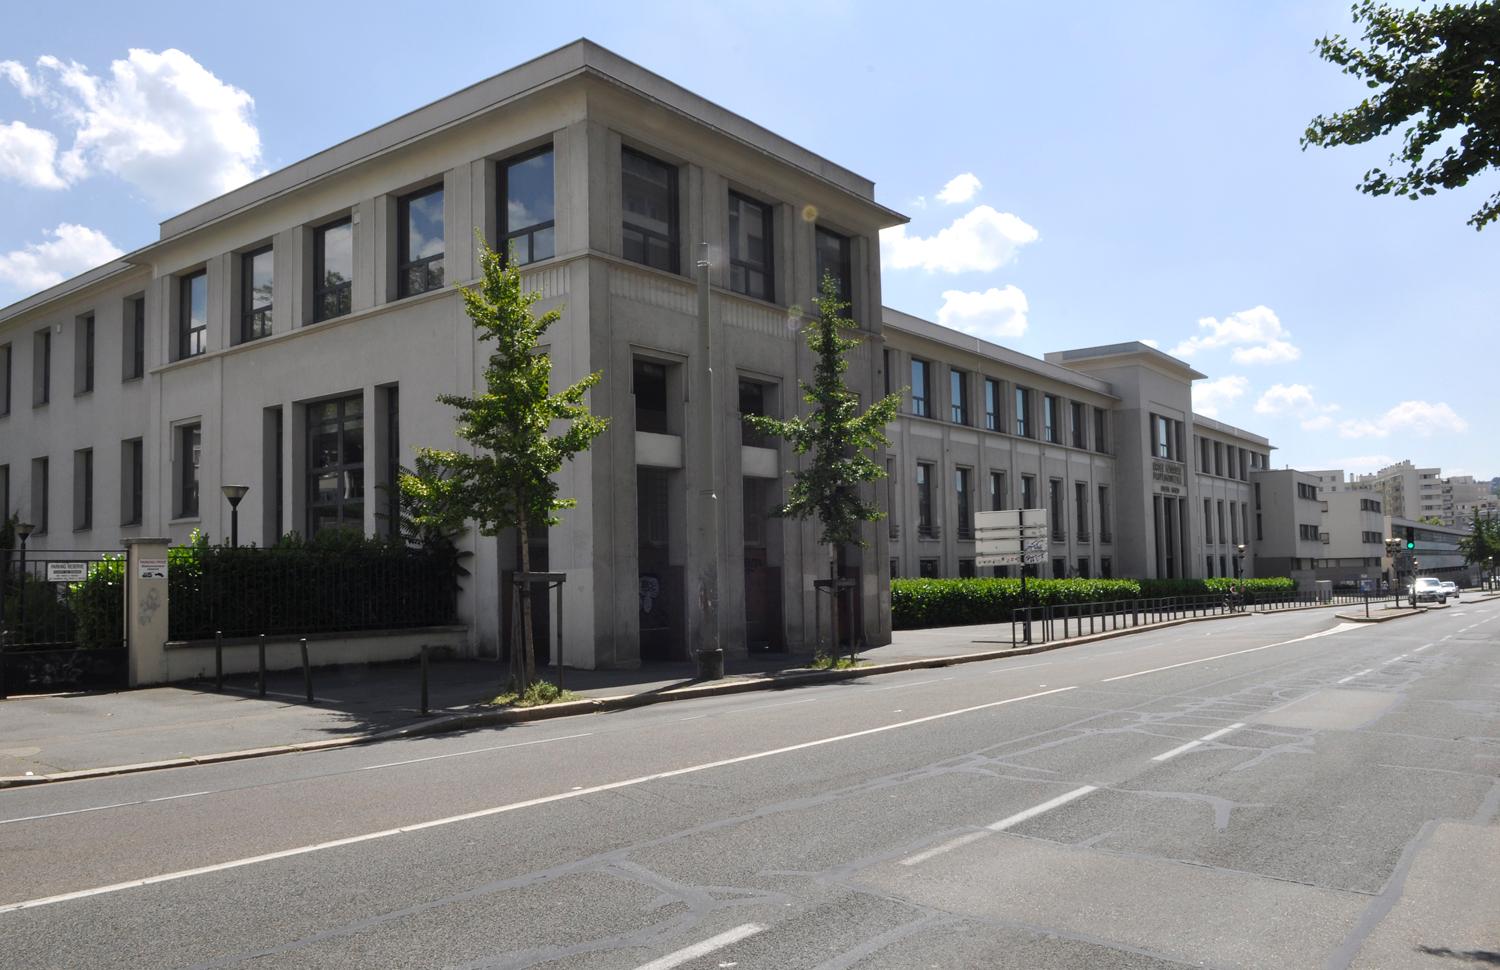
[0,0,1500,477]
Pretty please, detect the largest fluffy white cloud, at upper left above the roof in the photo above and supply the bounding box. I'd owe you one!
[0,48,261,208]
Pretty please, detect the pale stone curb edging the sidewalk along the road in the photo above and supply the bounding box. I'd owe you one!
[0,607,1272,790]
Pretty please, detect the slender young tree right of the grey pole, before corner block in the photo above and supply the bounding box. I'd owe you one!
[744,274,900,654]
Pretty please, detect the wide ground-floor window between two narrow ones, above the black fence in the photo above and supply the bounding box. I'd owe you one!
[308,394,365,538]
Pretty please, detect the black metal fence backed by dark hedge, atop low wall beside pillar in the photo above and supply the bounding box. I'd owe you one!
[167,546,458,640]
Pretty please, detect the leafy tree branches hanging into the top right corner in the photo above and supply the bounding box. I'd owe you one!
[1302,0,1500,229]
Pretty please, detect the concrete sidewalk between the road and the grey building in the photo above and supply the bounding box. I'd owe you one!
[0,615,1266,787]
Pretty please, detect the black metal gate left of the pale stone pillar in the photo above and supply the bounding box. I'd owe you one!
[0,549,128,697]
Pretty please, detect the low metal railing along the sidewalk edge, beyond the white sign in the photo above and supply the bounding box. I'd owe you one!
[1011,592,1392,646]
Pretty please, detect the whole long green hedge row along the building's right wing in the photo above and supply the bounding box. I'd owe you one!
[891,577,1298,630]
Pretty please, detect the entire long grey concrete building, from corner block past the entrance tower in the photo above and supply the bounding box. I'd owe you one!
[0,42,1302,667]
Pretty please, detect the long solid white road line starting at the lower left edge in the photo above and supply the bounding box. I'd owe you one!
[0,687,1077,915]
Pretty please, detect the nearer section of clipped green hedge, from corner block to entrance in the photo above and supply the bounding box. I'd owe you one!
[891,579,1142,630]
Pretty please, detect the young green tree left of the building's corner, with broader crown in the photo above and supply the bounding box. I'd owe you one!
[401,241,609,693]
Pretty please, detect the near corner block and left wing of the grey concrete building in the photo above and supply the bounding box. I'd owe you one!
[0,42,903,667]
